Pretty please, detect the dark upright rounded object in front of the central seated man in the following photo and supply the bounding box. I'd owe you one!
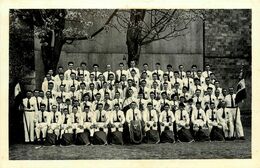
[129,120,143,144]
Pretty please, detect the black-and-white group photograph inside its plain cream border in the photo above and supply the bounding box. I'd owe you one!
[9,8,252,160]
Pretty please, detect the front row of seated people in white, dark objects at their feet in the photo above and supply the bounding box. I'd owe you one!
[31,98,234,145]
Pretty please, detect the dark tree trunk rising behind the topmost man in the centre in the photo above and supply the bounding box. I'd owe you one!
[126,9,145,66]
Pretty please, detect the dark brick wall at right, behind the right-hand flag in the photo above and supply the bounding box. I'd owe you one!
[204,9,251,110]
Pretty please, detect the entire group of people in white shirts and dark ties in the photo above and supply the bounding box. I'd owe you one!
[21,61,245,145]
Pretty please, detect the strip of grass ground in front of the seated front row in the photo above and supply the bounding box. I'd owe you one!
[9,127,251,160]
